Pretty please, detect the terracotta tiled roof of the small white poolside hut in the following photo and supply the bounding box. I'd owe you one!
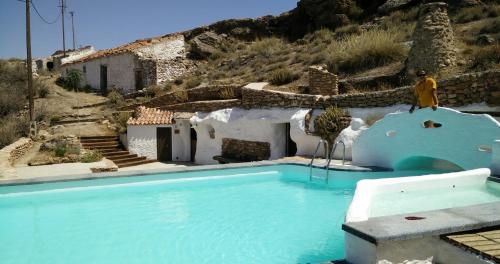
[127,106,175,126]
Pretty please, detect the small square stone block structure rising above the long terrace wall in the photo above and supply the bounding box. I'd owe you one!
[309,66,339,95]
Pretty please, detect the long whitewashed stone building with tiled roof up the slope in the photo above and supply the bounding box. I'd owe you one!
[61,34,188,94]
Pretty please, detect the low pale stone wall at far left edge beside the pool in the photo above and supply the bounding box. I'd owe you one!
[0,138,33,178]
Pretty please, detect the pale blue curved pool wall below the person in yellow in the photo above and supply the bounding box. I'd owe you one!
[352,108,500,170]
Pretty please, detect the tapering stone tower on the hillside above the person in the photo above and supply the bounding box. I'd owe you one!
[406,2,457,76]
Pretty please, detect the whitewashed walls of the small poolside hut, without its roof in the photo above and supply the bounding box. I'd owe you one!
[127,120,191,161]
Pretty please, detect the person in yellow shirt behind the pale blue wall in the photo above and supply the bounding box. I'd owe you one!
[410,71,439,113]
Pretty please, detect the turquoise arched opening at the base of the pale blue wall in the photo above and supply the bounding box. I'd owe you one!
[394,156,464,171]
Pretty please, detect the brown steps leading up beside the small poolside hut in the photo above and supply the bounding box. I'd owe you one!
[80,136,156,168]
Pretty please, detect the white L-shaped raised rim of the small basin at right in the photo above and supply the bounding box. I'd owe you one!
[346,168,491,222]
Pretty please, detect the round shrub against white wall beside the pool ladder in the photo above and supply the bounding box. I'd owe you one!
[314,106,350,145]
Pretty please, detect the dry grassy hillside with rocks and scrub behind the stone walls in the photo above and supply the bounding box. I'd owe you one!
[155,0,500,93]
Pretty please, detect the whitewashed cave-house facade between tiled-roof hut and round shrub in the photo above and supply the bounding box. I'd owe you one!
[190,108,323,164]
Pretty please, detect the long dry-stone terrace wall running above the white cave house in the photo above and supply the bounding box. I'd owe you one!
[147,70,500,112]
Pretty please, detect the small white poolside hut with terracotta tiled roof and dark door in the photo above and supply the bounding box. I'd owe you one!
[127,106,196,162]
